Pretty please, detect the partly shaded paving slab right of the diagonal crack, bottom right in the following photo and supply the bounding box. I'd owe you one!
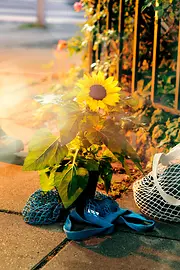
[43,232,180,270]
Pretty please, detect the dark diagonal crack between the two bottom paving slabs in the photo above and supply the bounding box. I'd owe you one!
[31,238,70,270]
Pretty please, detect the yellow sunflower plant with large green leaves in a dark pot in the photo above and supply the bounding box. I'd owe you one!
[23,72,141,211]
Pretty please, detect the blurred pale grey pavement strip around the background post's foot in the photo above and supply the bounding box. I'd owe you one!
[0,20,82,50]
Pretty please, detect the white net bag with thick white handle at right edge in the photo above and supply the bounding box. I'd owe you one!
[133,144,180,222]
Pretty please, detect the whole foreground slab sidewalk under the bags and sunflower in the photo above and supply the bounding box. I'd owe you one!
[0,163,180,270]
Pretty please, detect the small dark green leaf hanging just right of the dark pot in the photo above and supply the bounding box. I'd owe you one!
[99,160,113,193]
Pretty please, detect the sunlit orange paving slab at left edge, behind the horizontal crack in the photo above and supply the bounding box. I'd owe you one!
[0,162,40,212]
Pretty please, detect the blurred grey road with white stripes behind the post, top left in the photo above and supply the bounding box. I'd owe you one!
[0,0,84,24]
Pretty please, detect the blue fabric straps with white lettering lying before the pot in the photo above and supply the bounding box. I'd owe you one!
[63,193,155,240]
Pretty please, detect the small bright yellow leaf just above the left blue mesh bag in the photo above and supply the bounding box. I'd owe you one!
[38,168,55,192]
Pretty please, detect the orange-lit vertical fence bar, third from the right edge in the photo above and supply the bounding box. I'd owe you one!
[132,0,141,93]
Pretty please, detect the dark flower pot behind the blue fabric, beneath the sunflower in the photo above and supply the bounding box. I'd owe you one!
[75,171,99,215]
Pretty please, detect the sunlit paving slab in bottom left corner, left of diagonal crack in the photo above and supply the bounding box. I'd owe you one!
[0,213,65,270]
